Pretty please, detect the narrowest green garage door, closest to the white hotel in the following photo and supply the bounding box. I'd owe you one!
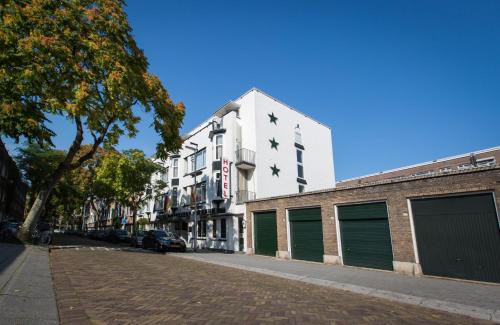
[254,211,278,256]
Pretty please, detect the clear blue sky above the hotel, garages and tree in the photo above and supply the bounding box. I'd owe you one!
[3,0,500,179]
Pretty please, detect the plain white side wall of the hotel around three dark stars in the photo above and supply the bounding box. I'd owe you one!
[254,91,335,198]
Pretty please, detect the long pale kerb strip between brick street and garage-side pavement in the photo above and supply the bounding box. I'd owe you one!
[175,254,500,322]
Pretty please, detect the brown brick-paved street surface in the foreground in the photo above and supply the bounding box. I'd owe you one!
[51,248,494,324]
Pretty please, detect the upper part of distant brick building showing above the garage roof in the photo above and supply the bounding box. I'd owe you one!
[337,147,500,188]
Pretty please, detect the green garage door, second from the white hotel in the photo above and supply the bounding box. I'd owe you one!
[288,208,324,262]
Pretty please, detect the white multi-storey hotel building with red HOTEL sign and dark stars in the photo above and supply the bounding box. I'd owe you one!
[143,88,335,251]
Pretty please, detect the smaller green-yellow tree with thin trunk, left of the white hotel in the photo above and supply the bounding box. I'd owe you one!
[96,149,166,232]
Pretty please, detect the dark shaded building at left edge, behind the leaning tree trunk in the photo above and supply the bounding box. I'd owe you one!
[0,139,28,221]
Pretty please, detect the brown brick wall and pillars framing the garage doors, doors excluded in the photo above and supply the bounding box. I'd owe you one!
[246,166,500,274]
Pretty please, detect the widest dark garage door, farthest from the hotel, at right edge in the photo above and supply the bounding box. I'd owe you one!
[412,193,500,282]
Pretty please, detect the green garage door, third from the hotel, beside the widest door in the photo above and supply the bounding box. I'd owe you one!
[338,202,393,270]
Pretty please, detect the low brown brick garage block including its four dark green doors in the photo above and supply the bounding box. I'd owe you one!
[247,166,500,282]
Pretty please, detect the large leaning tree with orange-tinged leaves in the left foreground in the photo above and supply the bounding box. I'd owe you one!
[0,0,184,240]
